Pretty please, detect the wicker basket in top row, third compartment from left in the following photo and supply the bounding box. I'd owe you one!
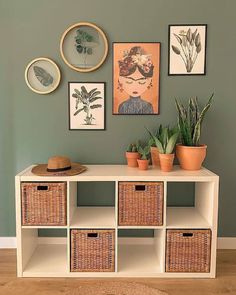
[119,182,163,226]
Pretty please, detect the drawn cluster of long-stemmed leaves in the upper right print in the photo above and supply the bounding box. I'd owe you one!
[171,28,202,73]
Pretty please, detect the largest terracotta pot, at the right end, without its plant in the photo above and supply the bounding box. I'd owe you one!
[176,144,207,170]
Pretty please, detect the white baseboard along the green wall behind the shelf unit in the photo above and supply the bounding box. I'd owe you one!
[0,237,236,249]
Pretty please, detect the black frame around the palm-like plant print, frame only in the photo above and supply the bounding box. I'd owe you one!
[68,81,106,131]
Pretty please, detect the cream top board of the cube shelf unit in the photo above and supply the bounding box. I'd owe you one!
[17,165,218,181]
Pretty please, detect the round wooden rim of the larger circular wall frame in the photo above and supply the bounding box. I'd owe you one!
[60,22,108,73]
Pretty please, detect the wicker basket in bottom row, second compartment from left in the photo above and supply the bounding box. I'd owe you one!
[71,229,115,272]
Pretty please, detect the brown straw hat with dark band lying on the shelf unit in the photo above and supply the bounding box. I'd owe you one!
[31,156,87,176]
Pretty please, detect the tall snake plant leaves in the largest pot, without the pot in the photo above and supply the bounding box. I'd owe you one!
[175,93,214,146]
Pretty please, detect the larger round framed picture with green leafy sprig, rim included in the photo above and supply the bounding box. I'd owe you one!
[60,23,108,72]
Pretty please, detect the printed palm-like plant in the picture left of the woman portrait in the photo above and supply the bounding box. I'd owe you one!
[72,86,103,125]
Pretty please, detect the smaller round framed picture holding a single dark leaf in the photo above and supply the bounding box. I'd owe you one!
[25,57,61,94]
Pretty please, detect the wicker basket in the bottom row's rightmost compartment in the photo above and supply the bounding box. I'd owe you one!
[166,229,211,272]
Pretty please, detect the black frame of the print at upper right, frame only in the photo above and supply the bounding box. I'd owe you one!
[168,24,208,76]
